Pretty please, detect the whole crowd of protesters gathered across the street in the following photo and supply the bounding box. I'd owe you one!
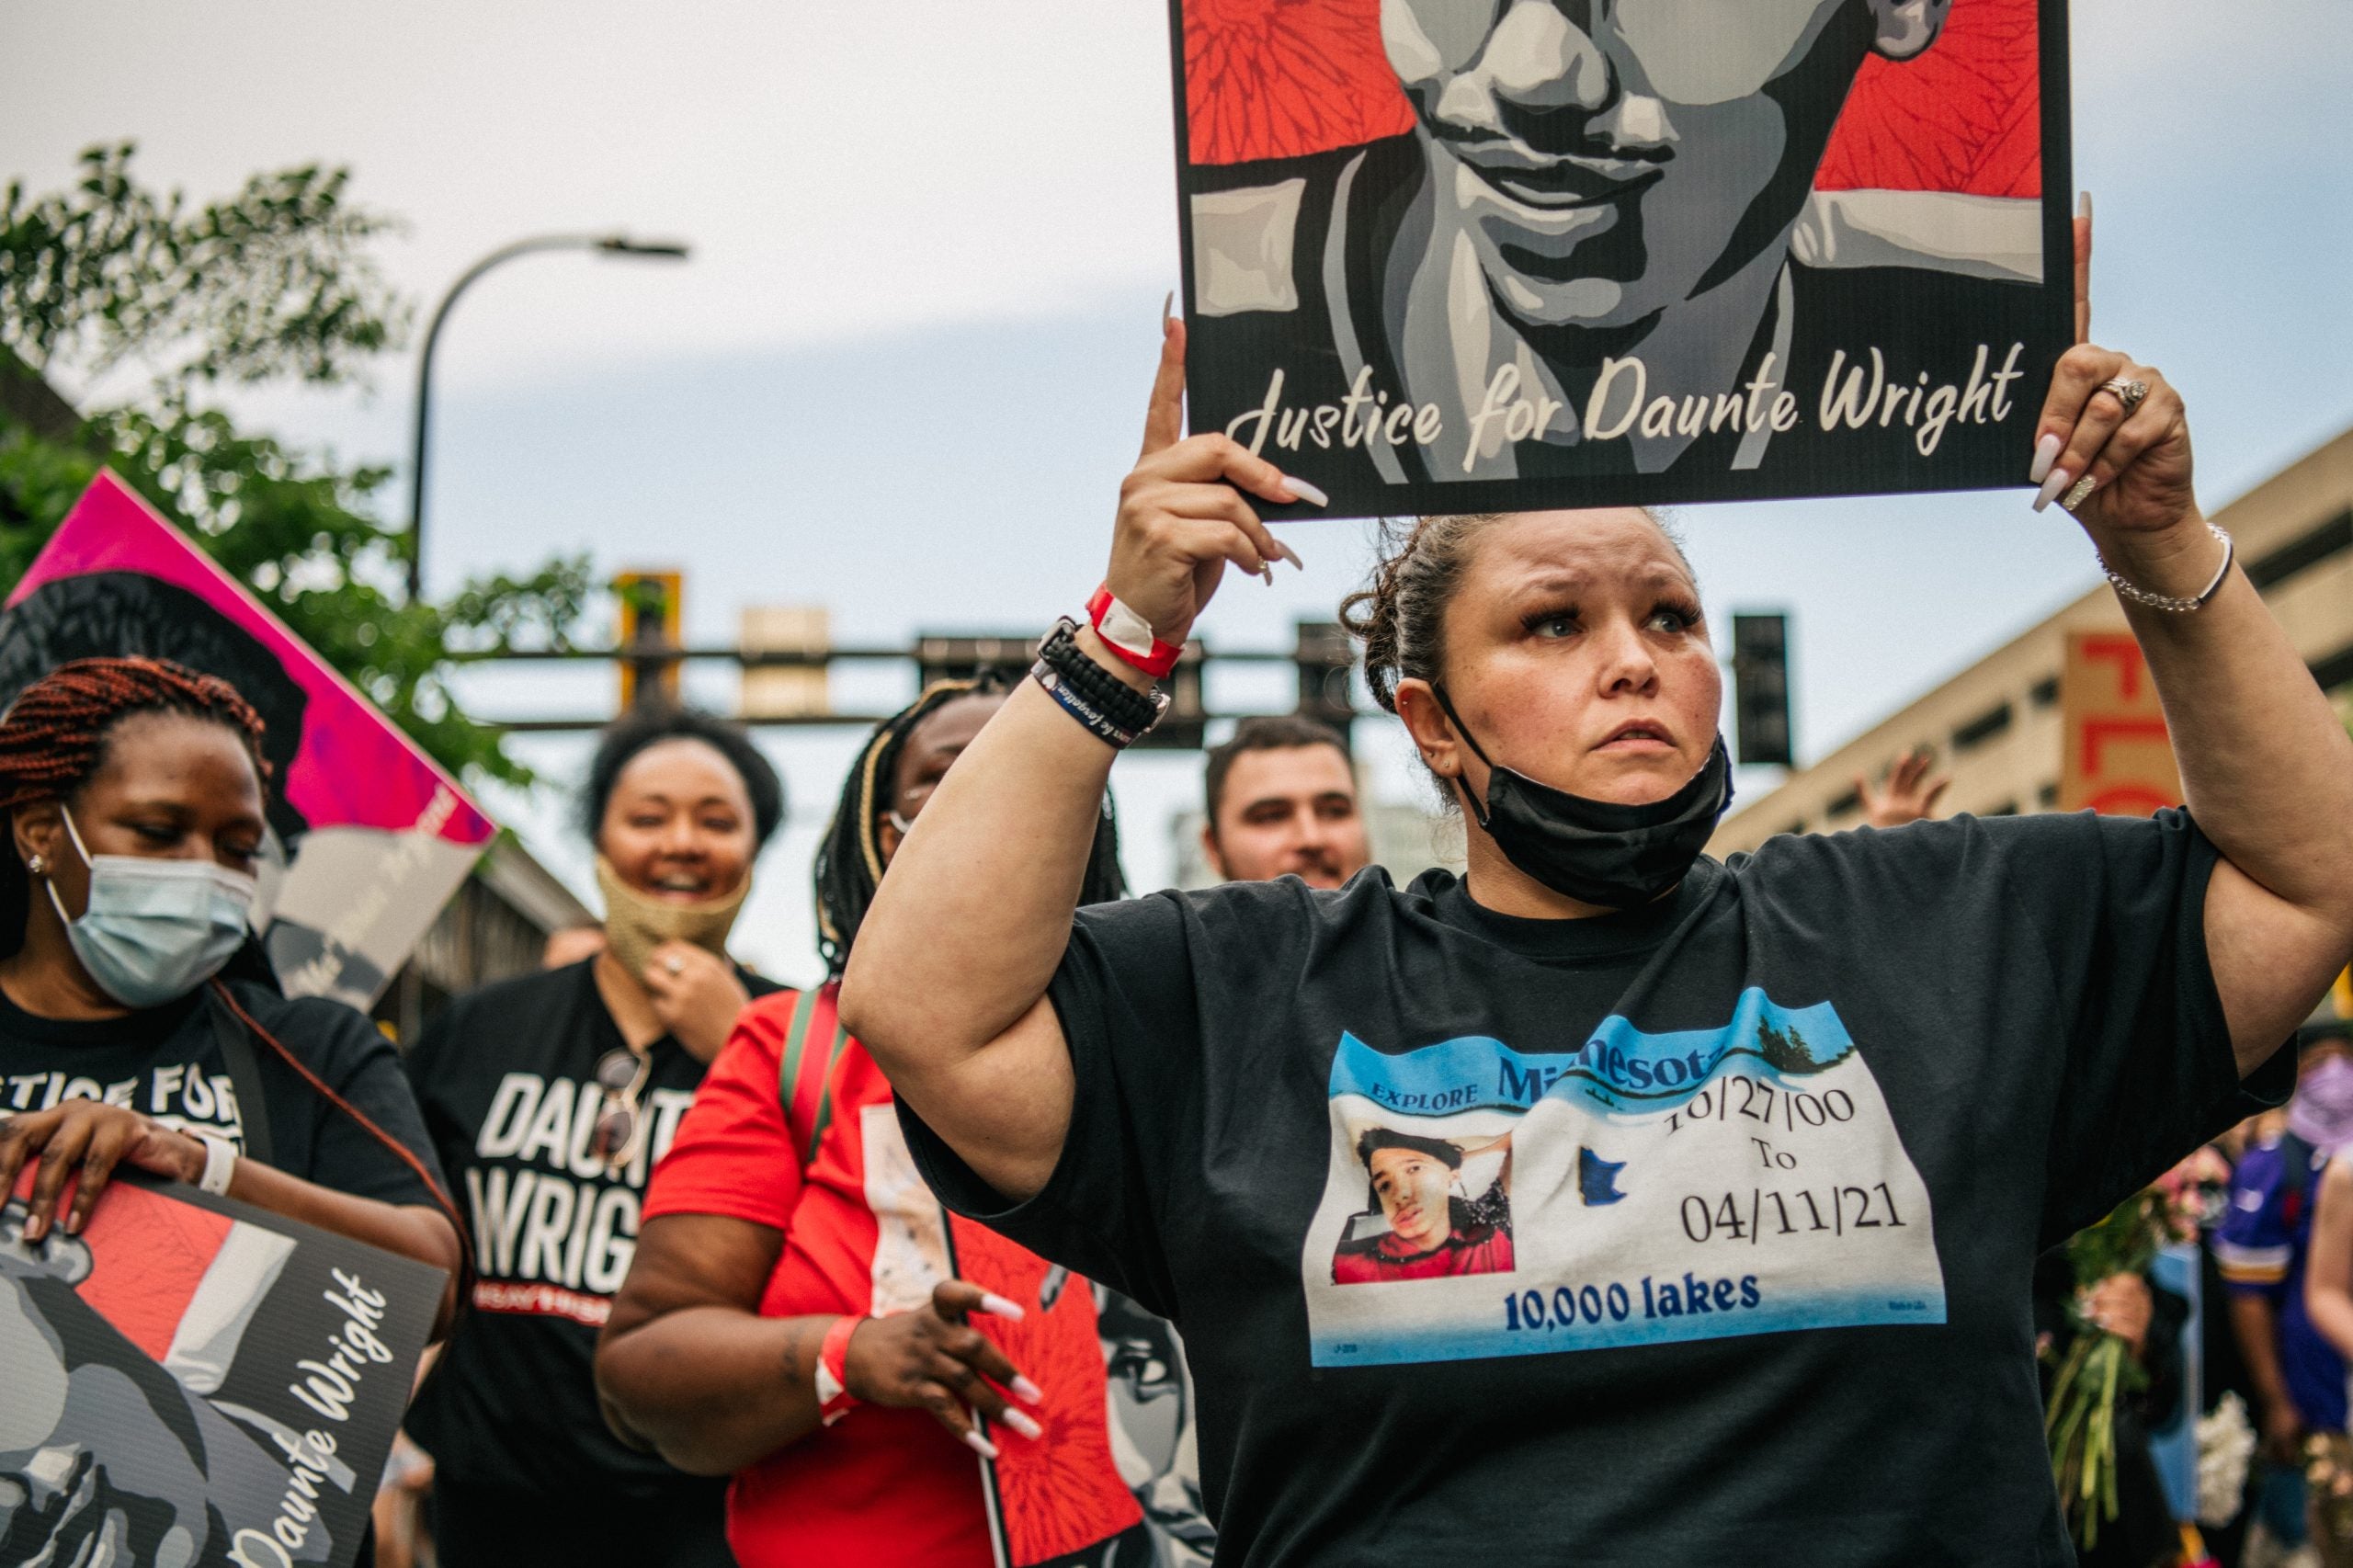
[0,306,2353,1568]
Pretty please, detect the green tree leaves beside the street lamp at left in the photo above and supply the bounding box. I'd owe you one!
[0,143,596,784]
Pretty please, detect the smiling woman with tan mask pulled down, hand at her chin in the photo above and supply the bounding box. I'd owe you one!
[407,709,783,1568]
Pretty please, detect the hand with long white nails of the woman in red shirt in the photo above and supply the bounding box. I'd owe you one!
[842,1278,1042,1460]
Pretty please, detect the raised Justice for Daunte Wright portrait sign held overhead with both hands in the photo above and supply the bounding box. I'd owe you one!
[1169,0,2073,516]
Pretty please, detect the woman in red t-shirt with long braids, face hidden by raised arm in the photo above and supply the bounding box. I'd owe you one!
[597,683,1166,1568]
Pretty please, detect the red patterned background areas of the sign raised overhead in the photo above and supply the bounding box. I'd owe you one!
[1184,0,2042,198]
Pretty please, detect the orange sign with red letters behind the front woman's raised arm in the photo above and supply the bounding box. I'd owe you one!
[2059,631,2181,817]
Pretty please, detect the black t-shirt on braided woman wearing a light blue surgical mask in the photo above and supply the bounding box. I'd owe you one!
[0,980,440,1206]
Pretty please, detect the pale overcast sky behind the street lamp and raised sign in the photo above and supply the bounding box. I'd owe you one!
[0,0,2353,977]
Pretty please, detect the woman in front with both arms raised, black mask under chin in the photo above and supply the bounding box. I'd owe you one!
[842,290,2353,1568]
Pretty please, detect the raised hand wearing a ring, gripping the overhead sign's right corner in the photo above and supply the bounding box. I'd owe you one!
[2029,344,2205,544]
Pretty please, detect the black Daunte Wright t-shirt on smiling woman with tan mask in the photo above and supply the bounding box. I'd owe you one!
[407,959,777,1506]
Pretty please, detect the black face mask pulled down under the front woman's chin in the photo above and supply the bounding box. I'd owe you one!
[1430,687,1732,909]
